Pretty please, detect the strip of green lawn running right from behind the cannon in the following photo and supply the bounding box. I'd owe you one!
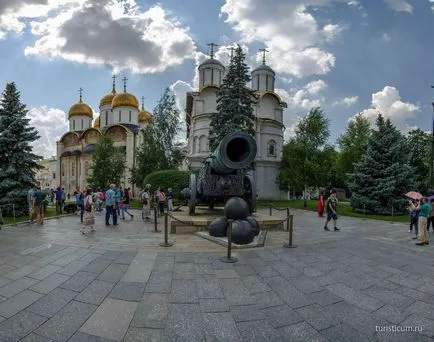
[258,200,410,222]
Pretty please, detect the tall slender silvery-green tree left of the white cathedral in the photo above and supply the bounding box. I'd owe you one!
[153,88,182,168]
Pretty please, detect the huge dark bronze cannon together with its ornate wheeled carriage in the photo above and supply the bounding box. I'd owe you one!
[182,132,257,215]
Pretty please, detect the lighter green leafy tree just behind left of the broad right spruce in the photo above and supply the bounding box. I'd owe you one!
[337,114,372,184]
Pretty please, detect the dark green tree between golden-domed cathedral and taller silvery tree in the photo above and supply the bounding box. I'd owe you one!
[131,126,169,186]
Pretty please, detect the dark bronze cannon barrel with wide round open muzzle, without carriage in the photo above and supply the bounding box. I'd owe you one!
[209,132,257,174]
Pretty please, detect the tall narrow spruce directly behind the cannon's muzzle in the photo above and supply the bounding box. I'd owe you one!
[209,45,256,151]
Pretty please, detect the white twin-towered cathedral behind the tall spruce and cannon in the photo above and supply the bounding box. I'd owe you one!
[186,44,287,199]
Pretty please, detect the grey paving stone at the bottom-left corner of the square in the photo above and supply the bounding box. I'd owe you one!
[0,310,47,341]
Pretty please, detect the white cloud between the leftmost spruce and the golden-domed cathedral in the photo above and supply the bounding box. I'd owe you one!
[27,106,68,158]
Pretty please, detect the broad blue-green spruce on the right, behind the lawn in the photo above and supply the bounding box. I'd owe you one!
[348,114,413,215]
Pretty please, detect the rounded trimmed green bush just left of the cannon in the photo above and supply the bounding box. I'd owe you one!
[144,170,191,198]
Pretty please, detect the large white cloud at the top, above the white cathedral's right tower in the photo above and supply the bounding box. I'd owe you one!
[221,0,348,77]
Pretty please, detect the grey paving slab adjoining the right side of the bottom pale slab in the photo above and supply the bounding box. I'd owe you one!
[131,293,169,329]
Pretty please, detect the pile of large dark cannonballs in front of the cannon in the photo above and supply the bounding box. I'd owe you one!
[209,197,259,245]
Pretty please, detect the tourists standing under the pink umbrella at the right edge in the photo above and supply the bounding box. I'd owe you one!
[408,198,434,246]
